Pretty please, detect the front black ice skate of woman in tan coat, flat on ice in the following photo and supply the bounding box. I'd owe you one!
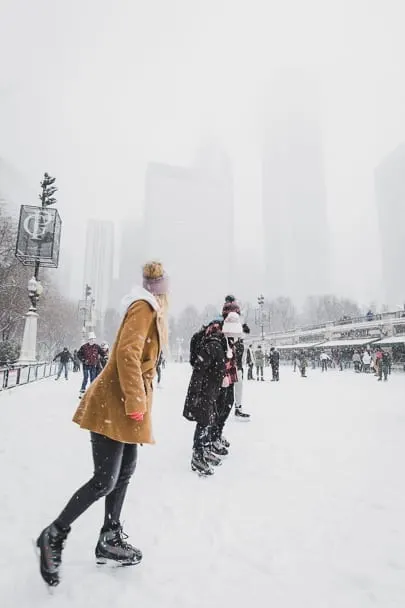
[95,524,142,566]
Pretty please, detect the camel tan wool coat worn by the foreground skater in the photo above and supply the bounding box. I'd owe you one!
[73,289,160,443]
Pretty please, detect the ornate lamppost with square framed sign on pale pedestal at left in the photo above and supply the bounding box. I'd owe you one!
[15,173,62,364]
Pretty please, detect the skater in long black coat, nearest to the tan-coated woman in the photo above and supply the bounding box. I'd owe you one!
[183,320,226,475]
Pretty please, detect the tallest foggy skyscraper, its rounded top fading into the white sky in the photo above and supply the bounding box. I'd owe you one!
[262,72,330,301]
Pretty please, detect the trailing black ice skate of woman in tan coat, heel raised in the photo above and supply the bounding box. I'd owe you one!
[37,524,70,587]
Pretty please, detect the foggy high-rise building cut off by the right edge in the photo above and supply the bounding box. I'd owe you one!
[374,143,405,306]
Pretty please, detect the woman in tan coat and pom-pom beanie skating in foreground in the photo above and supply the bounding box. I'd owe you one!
[37,262,167,586]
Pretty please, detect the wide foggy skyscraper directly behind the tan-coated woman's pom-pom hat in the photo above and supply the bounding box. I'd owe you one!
[145,154,234,310]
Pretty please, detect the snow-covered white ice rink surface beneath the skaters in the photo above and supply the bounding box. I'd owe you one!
[0,364,405,608]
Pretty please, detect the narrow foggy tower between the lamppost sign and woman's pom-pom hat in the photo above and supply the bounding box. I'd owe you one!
[83,220,114,326]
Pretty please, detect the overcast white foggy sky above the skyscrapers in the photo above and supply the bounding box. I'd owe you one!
[0,0,405,301]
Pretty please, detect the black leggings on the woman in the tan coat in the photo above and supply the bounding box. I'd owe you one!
[55,433,138,531]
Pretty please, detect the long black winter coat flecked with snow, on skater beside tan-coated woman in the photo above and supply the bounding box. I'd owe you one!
[183,332,226,426]
